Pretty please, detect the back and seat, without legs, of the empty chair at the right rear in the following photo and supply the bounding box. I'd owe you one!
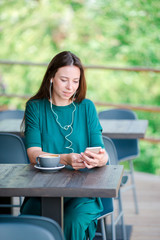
[99,109,139,161]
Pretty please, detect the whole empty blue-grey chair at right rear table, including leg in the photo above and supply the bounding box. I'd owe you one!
[99,109,139,213]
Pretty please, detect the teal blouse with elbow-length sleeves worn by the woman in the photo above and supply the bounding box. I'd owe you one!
[25,99,104,154]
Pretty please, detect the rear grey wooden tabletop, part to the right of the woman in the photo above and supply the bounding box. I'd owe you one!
[100,119,148,139]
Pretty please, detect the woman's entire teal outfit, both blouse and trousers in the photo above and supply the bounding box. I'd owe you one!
[22,99,104,240]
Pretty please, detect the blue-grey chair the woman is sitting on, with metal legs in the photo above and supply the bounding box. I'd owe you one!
[98,137,126,240]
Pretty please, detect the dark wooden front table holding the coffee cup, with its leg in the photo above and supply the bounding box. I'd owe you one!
[0,164,123,229]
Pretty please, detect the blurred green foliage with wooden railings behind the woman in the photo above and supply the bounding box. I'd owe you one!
[0,0,160,175]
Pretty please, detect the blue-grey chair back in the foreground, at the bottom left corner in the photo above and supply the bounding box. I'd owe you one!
[0,215,64,240]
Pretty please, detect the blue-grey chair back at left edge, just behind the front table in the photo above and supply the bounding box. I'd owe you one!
[0,133,29,164]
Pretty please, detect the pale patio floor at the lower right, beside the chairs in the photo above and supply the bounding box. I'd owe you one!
[122,172,160,240]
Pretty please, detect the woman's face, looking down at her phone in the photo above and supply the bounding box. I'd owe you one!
[52,66,80,105]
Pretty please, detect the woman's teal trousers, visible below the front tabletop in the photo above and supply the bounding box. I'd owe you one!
[21,198,103,240]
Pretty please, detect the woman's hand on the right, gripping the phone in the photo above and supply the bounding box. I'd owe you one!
[81,149,108,168]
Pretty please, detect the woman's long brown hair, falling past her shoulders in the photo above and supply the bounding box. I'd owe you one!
[28,51,87,102]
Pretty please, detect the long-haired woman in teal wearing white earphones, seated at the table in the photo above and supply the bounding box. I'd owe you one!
[21,51,108,240]
